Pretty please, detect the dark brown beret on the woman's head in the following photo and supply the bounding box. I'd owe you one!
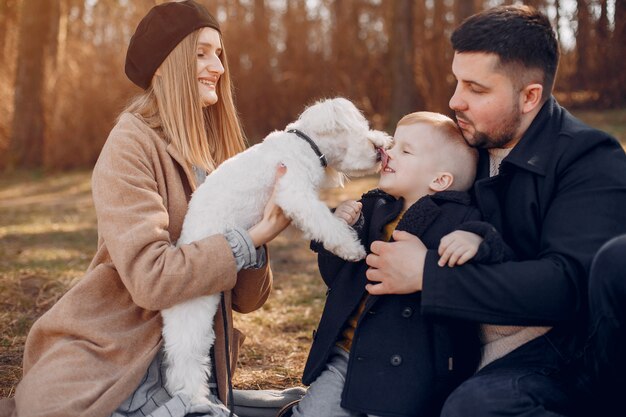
[124,0,220,90]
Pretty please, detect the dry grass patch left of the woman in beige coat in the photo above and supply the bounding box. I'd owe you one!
[0,172,97,397]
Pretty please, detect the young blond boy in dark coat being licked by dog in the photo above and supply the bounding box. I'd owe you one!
[293,112,509,417]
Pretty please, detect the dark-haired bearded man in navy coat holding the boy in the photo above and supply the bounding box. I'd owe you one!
[366,6,626,417]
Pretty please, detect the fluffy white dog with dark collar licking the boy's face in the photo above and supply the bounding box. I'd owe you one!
[162,98,391,403]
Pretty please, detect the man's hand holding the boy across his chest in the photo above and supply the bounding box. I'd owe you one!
[365,230,426,295]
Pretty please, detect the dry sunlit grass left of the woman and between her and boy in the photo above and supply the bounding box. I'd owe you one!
[0,171,375,397]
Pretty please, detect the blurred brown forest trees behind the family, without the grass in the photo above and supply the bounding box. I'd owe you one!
[0,0,626,170]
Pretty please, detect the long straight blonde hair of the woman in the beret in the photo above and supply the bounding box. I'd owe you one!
[122,29,246,172]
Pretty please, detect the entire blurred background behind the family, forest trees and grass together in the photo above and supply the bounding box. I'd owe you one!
[0,0,626,397]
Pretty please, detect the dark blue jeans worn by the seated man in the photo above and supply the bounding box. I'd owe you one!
[441,235,626,417]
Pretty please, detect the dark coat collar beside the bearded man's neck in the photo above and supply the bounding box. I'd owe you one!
[492,97,563,177]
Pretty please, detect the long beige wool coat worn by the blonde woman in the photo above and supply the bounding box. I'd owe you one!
[0,114,272,417]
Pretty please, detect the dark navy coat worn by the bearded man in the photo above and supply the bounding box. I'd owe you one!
[422,98,626,360]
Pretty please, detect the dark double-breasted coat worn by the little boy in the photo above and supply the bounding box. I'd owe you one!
[303,190,505,416]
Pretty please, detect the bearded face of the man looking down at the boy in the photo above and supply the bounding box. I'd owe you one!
[450,52,523,148]
